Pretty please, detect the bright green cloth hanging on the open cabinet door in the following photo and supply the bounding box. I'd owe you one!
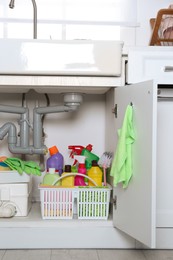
[110,105,135,188]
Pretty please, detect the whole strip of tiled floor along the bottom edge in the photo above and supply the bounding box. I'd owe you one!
[0,249,173,260]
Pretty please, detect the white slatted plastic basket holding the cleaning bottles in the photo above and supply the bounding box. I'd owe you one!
[39,175,111,219]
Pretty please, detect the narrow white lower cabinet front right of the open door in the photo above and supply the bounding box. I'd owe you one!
[157,92,173,228]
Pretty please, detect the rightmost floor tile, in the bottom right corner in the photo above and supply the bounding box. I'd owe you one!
[143,250,173,260]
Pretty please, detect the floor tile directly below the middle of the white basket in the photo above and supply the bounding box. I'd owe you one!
[51,249,99,260]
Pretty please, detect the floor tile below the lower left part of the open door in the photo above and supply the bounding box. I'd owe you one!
[98,249,146,260]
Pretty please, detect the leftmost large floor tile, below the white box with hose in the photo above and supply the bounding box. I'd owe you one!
[3,249,51,260]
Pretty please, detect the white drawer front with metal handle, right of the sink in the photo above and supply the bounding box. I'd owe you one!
[128,46,173,84]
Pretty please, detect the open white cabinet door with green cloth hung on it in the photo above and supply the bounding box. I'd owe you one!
[113,81,157,248]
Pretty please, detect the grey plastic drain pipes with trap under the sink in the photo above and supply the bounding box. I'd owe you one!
[0,93,83,154]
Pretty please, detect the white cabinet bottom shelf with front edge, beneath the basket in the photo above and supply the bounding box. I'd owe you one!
[0,203,135,249]
